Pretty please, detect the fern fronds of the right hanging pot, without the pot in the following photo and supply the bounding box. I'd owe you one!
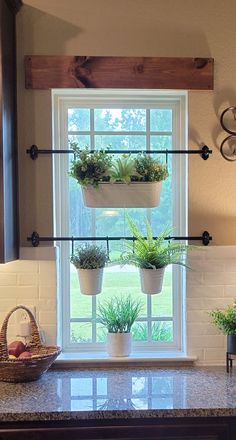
[122,217,188,269]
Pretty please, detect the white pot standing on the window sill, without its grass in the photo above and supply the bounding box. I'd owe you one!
[107,333,132,357]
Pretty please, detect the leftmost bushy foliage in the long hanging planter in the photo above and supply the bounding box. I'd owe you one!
[70,143,112,187]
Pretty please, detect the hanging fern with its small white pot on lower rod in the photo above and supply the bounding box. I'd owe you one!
[121,217,188,294]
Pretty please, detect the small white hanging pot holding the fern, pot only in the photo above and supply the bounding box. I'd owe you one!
[139,267,165,295]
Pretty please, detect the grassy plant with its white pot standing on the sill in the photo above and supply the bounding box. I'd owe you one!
[98,296,142,357]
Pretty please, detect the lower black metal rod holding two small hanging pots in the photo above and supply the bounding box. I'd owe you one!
[27,231,212,247]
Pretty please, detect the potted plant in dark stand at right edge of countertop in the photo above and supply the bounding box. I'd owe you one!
[209,300,236,354]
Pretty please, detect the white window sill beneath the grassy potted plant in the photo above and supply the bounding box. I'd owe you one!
[54,351,197,368]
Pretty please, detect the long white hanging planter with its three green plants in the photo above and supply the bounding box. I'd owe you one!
[70,144,168,208]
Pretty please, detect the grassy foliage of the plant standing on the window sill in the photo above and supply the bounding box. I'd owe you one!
[97,296,142,333]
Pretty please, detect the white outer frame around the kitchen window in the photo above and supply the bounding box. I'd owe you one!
[52,89,188,353]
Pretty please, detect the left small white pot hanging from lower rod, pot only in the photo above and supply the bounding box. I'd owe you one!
[77,268,103,295]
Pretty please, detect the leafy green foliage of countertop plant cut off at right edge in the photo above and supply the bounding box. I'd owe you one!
[209,300,236,336]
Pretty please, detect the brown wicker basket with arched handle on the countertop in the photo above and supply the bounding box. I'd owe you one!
[0,305,61,382]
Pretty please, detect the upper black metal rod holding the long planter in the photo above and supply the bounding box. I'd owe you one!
[26,145,212,160]
